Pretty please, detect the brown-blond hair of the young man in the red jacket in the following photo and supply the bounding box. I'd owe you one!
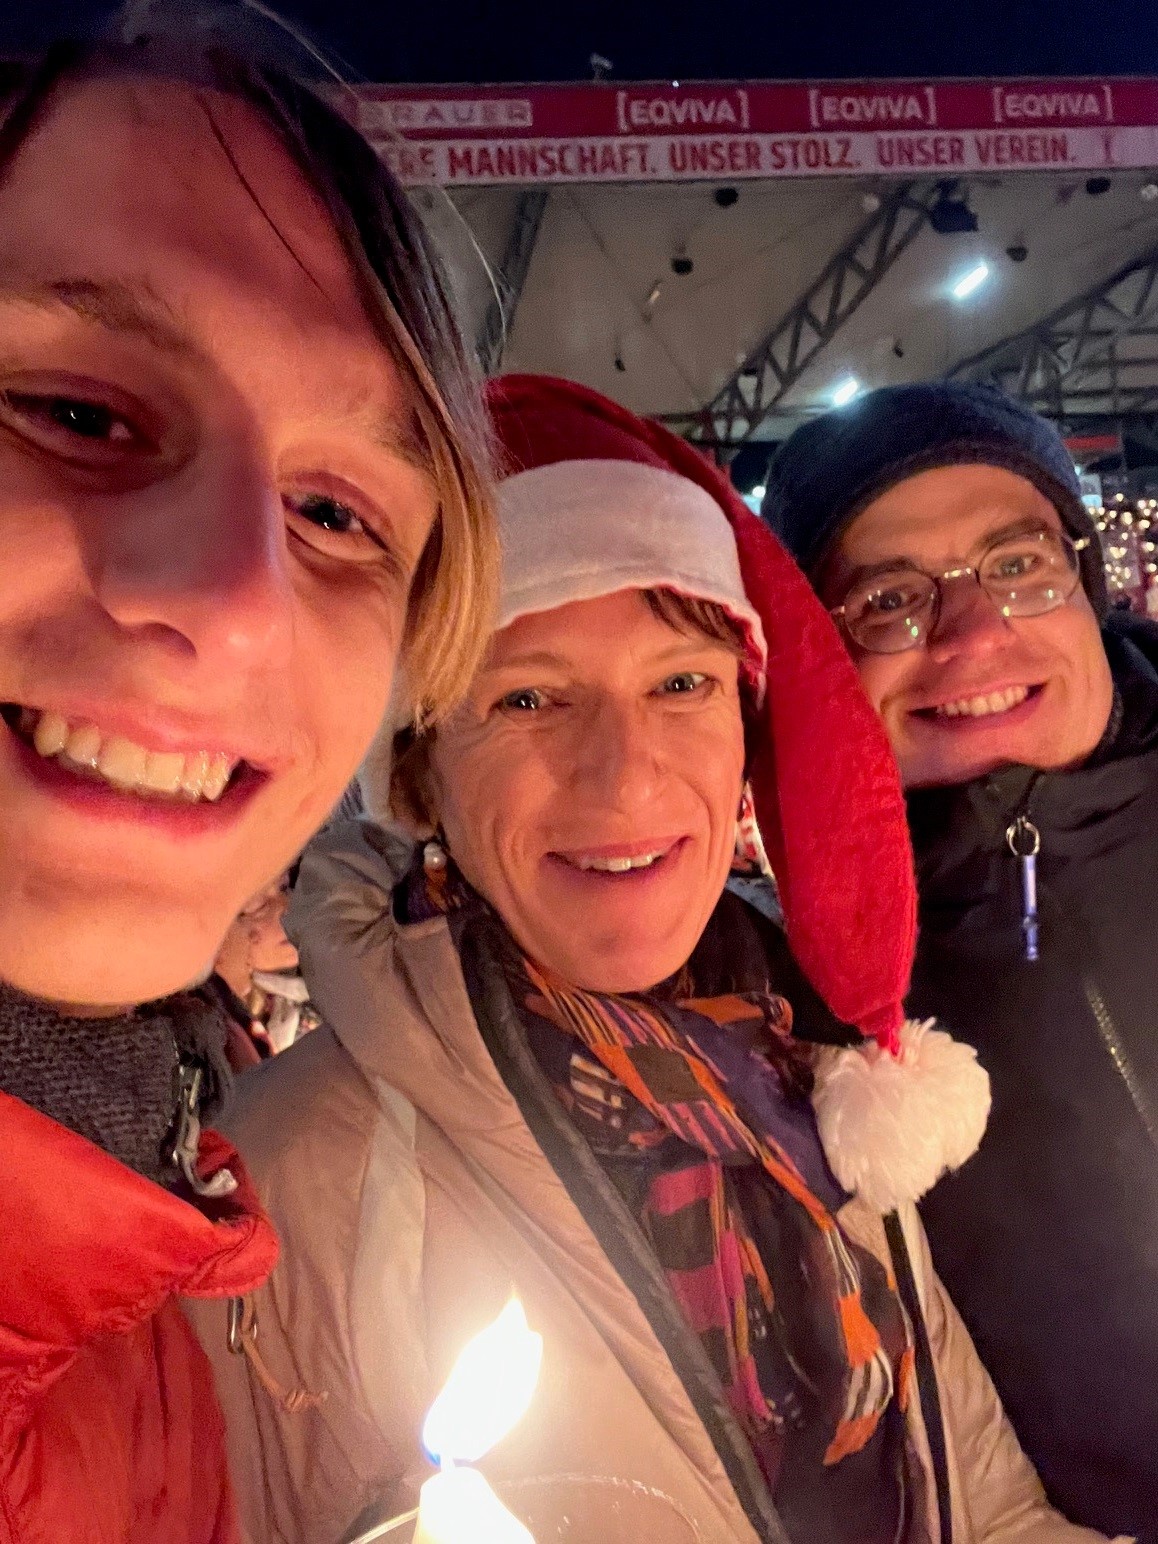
[0,29,499,721]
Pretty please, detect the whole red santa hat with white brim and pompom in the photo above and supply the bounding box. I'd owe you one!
[488,375,988,1207]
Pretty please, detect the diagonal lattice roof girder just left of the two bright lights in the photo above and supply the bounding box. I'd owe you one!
[684,182,937,445]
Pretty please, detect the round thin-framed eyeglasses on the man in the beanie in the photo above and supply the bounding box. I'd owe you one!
[832,531,1090,655]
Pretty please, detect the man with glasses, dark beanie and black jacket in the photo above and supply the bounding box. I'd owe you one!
[764,383,1158,1544]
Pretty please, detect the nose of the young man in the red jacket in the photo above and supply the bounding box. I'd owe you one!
[86,443,293,670]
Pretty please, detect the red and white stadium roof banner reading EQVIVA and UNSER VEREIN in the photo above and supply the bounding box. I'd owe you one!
[358,79,1158,187]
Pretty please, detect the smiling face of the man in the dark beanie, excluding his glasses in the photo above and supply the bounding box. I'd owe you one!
[820,466,1113,787]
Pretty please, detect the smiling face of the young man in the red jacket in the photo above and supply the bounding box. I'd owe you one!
[0,79,435,1005]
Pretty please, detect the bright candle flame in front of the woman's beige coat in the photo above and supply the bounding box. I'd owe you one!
[422,1297,543,1464]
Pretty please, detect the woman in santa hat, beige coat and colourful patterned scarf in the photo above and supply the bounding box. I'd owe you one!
[202,377,1117,1544]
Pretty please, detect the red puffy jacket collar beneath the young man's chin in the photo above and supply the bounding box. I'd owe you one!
[0,1093,278,1366]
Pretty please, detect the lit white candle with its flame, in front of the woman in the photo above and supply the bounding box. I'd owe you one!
[414,1297,543,1544]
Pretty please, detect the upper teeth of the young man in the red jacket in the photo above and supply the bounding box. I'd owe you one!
[22,709,236,801]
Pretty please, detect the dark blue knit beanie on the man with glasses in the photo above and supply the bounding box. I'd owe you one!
[763,381,1109,616]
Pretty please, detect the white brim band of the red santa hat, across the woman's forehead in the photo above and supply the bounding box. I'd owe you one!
[499,460,767,675]
